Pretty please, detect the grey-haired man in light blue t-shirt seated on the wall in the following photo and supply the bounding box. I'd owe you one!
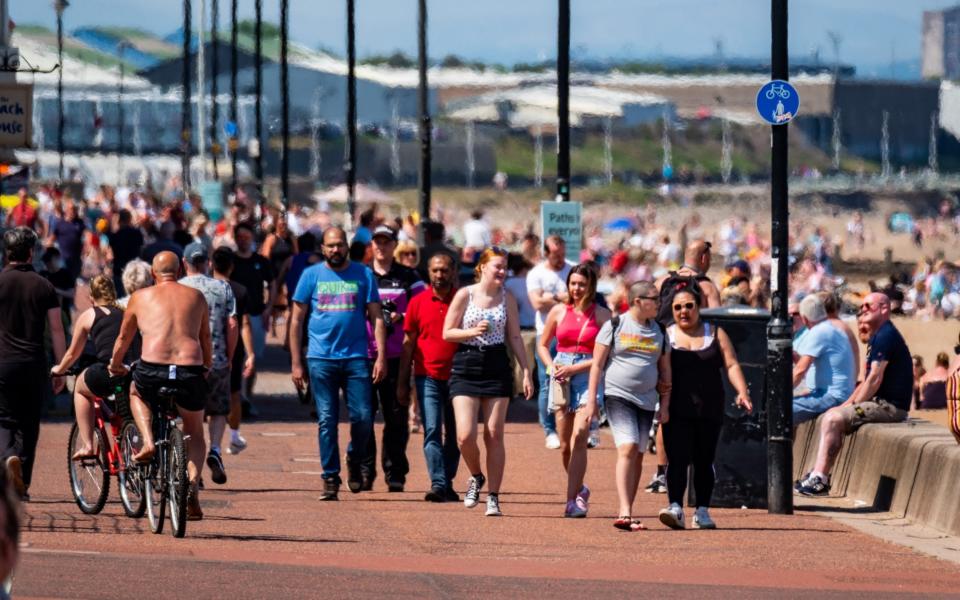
[793,294,856,426]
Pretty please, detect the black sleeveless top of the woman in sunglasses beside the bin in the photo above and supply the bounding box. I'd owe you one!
[668,325,725,421]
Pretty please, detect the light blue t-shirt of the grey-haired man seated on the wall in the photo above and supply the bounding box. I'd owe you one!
[796,321,856,400]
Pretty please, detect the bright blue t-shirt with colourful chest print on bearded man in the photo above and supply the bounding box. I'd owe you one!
[293,262,380,359]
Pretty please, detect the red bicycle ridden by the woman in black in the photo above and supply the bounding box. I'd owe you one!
[67,366,146,519]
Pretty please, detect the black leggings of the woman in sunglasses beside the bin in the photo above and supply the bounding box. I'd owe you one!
[663,418,723,506]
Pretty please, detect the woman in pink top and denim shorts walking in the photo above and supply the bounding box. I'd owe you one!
[537,264,610,517]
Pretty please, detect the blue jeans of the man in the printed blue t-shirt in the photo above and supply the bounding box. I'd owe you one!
[307,358,373,483]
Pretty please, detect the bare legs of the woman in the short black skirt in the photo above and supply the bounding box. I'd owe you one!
[453,396,508,494]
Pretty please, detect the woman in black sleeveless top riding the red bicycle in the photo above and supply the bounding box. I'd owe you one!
[50,275,140,460]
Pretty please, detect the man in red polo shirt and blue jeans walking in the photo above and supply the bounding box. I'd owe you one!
[397,253,460,502]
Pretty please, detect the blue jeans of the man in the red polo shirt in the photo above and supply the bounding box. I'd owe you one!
[416,375,460,489]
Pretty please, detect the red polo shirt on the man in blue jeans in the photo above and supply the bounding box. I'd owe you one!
[403,289,457,381]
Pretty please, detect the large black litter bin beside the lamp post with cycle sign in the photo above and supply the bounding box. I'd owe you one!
[689,307,770,508]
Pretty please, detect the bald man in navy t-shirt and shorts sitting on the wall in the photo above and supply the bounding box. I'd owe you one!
[796,292,913,496]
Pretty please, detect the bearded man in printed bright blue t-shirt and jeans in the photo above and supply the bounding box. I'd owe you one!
[290,227,387,500]
